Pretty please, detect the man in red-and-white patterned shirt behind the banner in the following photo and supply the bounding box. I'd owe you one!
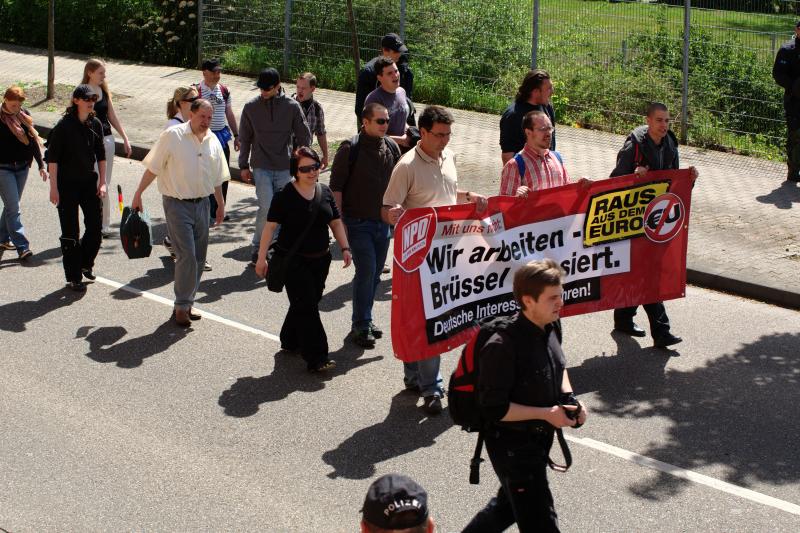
[500,111,570,196]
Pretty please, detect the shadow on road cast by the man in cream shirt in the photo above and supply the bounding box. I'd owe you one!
[75,318,191,368]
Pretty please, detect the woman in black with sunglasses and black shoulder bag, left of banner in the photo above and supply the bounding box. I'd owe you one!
[256,147,352,372]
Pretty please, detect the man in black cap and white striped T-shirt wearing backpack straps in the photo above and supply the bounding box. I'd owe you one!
[196,59,239,227]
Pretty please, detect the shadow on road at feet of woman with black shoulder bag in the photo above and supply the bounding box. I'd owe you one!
[217,344,383,418]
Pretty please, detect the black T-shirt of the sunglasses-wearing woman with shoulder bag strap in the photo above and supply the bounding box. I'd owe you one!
[267,182,340,254]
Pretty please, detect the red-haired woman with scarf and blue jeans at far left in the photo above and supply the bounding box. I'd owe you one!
[0,86,47,261]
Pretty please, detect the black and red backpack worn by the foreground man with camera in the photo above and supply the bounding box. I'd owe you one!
[447,315,572,485]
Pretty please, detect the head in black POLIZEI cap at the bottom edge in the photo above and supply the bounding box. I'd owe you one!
[361,474,435,533]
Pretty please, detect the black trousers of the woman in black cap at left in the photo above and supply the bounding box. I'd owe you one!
[58,180,103,281]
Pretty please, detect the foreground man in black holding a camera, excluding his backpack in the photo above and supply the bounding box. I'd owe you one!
[464,259,586,533]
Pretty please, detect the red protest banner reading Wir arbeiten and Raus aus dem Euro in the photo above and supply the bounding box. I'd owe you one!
[392,170,693,362]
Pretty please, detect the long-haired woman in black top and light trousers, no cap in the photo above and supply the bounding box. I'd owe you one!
[81,59,131,237]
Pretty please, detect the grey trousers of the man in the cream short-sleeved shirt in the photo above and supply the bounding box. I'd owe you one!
[163,196,209,311]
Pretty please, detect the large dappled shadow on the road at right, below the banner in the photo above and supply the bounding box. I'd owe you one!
[569,333,800,501]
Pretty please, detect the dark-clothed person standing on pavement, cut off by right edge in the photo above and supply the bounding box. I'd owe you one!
[772,20,800,182]
